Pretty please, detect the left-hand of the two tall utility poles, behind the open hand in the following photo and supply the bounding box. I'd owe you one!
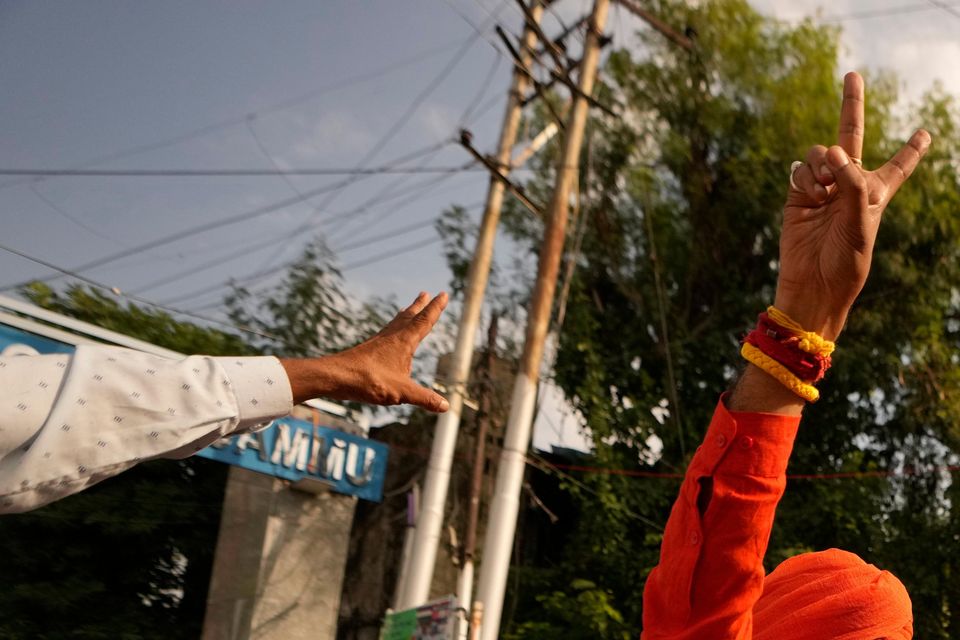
[398,0,543,609]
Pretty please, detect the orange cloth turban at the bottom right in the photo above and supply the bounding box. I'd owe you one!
[753,549,913,640]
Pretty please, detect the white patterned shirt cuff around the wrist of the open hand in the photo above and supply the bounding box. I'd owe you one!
[213,356,293,431]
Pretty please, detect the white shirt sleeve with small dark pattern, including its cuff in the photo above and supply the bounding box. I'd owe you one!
[0,345,293,513]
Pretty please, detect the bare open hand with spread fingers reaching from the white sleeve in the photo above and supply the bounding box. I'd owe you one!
[281,293,450,412]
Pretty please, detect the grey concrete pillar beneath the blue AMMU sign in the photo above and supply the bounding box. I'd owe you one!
[202,467,356,640]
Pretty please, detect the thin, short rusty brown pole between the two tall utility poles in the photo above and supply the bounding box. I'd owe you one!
[457,313,500,640]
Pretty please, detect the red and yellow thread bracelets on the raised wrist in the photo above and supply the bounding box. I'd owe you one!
[740,306,835,402]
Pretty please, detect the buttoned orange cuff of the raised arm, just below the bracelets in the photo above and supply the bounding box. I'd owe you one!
[696,396,800,478]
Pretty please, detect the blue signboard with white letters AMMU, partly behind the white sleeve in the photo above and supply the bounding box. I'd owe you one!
[0,324,388,502]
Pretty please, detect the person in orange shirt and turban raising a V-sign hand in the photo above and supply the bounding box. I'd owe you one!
[642,73,930,640]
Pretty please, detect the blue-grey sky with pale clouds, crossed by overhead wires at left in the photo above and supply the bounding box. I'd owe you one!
[0,0,960,444]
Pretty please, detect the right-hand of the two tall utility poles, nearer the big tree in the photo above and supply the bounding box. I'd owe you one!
[477,0,610,640]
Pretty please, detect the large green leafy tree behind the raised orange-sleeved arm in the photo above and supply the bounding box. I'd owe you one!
[480,0,960,638]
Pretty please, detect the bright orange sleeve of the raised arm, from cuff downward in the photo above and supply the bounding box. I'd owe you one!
[642,398,800,640]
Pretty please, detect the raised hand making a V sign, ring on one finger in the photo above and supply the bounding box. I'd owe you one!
[775,73,930,340]
